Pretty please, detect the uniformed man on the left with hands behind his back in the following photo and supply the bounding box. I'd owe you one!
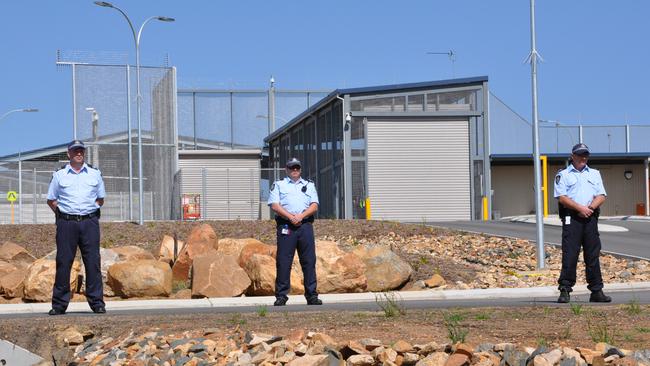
[47,140,106,315]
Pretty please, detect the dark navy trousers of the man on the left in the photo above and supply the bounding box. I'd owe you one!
[52,217,105,311]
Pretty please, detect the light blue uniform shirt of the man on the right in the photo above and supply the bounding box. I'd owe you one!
[554,164,607,206]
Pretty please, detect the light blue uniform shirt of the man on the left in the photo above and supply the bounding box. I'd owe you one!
[47,163,106,215]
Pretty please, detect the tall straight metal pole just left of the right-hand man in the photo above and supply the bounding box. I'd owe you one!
[530,0,545,269]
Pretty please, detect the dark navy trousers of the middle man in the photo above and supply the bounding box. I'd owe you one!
[275,223,318,299]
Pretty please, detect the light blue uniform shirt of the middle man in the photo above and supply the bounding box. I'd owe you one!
[268,177,319,214]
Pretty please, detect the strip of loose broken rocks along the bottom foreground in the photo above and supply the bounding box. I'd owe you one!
[35,327,650,366]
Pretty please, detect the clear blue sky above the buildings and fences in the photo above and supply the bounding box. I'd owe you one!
[0,0,650,155]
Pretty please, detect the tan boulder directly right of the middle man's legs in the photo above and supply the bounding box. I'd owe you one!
[316,240,367,294]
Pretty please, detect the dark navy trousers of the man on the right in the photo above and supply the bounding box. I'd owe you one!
[558,215,603,291]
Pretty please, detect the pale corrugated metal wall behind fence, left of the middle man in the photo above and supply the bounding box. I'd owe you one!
[178,152,261,220]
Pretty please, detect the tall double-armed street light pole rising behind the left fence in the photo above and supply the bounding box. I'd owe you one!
[95,1,175,225]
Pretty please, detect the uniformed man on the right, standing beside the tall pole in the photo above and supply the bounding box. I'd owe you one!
[555,144,612,303]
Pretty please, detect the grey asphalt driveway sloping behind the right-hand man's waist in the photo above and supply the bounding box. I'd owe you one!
[428,220,650,260]
